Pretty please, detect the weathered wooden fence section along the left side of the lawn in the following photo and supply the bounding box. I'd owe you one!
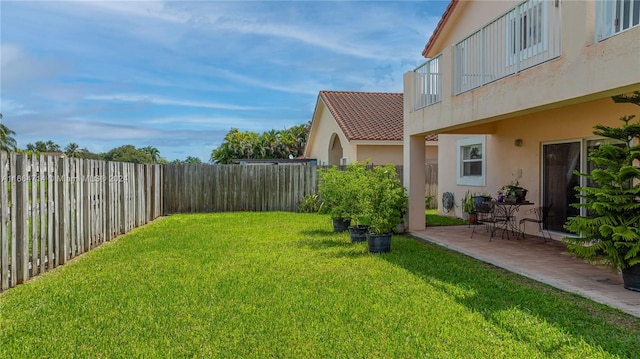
[0,152,162,291]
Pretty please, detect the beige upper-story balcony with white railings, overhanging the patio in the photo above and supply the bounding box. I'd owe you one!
[410,0,640,134]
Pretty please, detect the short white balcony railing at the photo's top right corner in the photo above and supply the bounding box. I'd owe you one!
[596,0,640,41]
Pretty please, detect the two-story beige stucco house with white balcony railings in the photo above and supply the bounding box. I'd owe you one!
[404,0,640,239]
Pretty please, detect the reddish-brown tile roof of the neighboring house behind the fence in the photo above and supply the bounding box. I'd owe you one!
[320,91,403,141]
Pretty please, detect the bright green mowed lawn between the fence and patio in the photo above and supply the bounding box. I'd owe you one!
[0,213,640,358]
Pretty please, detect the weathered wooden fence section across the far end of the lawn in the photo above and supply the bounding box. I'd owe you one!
[164,165,318,214]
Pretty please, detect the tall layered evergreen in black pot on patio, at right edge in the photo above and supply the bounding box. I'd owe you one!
[563,91,640,291]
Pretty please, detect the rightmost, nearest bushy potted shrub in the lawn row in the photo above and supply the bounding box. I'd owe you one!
[363,165,407,253]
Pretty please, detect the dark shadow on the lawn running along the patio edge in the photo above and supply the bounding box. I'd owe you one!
[379,236,640,357]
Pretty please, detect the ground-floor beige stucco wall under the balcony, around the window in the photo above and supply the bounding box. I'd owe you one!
[438,99,640,236]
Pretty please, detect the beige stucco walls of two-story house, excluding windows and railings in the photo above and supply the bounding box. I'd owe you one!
[404,1,640,229]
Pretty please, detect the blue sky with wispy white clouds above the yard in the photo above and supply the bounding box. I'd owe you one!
[0,0,448,162]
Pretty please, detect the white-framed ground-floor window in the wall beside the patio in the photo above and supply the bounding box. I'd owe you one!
[457,136,486,186]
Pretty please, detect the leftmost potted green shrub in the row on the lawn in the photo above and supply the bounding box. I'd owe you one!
[318,166,351,232]
